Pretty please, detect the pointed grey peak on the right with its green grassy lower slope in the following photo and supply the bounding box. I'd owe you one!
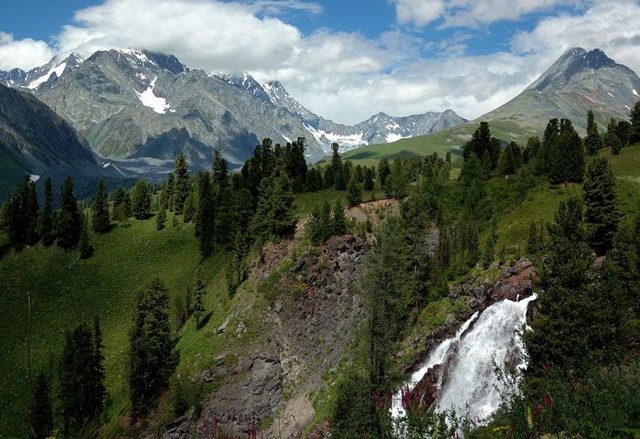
[345,48,640,165]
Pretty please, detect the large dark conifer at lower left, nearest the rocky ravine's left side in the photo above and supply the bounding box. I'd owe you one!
[129,278,178,416]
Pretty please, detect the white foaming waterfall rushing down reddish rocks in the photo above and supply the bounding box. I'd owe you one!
[391,295,537,422]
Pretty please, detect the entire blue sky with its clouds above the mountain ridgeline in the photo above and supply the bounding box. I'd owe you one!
[0,0,640,123]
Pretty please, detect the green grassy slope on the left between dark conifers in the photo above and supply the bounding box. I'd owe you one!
[0,213,226,437]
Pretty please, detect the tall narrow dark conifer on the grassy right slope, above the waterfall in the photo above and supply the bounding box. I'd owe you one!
[583,157,620,255]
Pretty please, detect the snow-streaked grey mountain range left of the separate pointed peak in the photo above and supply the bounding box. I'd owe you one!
[0,49,465,174]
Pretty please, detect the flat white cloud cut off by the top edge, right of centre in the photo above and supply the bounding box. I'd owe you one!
[392,0,580,27]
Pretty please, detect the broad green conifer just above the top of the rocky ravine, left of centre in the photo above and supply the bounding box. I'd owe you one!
[251,165,296,239]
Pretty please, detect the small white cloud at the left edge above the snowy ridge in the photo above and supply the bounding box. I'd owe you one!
[0,32,54,70]
